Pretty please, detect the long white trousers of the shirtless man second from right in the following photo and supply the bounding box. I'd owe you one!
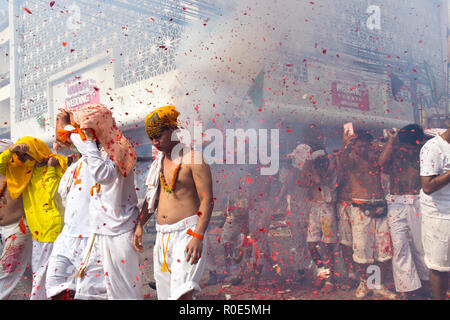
[386,195,429,292]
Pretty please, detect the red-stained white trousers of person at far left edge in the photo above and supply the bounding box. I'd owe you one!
[0,222,32,300]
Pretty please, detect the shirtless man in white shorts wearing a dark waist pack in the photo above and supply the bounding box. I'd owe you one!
[339,130,396,299]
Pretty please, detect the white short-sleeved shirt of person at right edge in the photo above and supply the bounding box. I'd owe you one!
[420,135,450,219]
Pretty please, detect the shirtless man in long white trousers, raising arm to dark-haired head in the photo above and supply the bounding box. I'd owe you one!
[378,124,429,298]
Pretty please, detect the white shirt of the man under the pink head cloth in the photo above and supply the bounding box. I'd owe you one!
[84,141,139,235]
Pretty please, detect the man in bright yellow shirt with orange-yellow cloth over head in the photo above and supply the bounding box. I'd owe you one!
[0,137,67,299]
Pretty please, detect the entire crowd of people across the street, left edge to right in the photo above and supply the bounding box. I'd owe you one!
[0,104,450,300]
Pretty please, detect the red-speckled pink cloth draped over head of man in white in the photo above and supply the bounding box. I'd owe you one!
[73,104,137,177]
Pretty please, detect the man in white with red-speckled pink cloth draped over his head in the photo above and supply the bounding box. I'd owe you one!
[59,104,143,300]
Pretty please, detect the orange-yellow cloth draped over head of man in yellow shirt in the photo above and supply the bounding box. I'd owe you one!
[6,137,67,199]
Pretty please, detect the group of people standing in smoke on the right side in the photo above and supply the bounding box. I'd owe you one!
[210,124,450,299]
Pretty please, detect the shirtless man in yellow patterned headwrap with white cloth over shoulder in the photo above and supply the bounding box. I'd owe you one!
[134,106,214,300]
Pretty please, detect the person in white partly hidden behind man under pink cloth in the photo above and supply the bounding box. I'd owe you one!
[46,111,99,300]
